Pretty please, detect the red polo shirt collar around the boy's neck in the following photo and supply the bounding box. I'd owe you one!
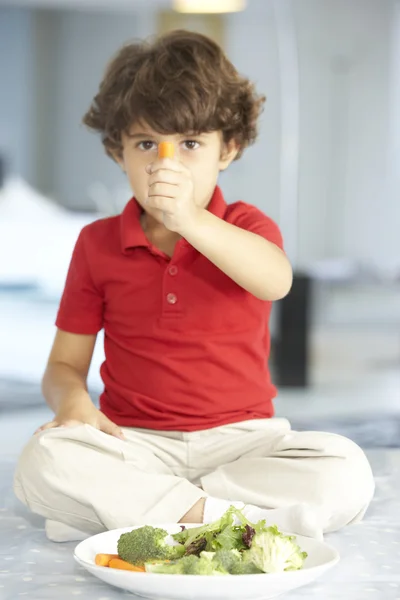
[121,186,227,252]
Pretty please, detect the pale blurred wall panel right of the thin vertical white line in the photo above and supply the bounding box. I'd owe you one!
[293,0,398,263]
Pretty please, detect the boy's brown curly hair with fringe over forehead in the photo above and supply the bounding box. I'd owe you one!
[83,30,265,158]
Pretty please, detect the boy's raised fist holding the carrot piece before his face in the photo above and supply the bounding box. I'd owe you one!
[146,158,202,237]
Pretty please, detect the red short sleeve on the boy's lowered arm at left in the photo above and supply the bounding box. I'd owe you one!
[56,228,104,335]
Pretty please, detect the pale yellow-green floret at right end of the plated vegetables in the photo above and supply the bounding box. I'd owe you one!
[242,527,307,573]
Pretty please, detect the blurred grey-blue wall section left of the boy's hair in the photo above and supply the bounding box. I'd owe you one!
[55,12,158,212]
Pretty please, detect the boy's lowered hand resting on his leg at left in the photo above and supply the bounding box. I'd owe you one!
[35,406,126,440]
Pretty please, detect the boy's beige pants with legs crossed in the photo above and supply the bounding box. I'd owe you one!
[14,419,374,533]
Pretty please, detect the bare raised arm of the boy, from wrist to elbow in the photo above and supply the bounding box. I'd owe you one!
[180,210,293,301]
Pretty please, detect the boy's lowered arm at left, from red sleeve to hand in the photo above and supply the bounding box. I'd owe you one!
[37,226,124,439]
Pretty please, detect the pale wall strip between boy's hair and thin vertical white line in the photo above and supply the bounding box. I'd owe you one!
[221,2,280,226]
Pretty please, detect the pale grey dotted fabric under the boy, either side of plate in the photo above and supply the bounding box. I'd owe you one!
[0,449,400,600]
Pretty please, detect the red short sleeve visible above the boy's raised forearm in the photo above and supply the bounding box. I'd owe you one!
[230,202,284,250]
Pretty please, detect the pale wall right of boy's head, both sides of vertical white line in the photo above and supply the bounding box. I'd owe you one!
[214,0,400,266]
